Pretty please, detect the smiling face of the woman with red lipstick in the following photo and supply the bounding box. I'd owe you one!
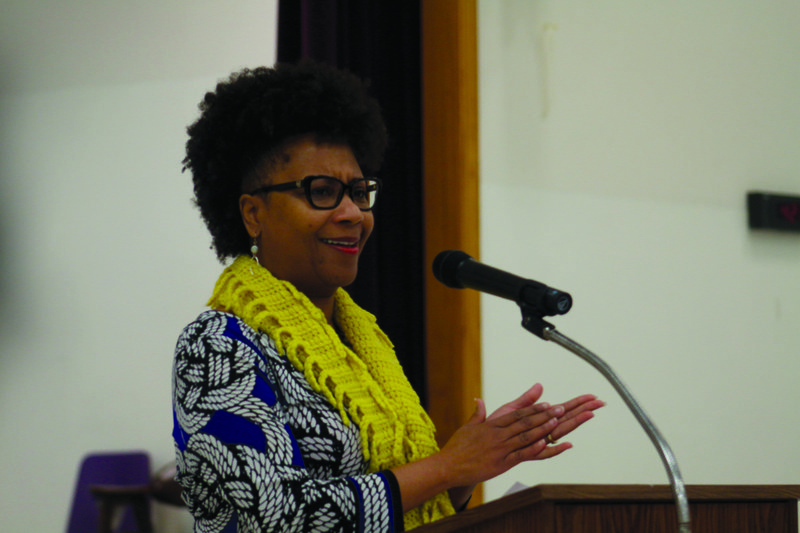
[240,138,374,299]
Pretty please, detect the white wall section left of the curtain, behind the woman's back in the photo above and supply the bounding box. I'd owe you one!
[0,0,276,531]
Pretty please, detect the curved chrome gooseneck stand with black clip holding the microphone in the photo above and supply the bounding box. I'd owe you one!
[520,303,691,533]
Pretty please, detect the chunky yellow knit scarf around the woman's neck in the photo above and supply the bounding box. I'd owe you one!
[208,256,454,530]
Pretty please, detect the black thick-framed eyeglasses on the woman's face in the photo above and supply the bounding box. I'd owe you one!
[250,176,381,211]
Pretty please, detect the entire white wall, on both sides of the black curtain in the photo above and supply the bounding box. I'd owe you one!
[0,0,800,531]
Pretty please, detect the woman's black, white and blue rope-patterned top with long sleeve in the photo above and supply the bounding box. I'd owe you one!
[173,311,403,533]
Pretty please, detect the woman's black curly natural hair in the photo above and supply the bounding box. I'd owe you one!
[183,61,387,261]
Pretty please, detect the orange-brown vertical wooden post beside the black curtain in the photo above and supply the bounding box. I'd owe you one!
[421,0,482,504]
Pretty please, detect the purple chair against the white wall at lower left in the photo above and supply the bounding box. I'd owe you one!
[67,452,153,533]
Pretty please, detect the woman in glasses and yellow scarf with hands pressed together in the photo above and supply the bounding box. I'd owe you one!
[173,63,603,532]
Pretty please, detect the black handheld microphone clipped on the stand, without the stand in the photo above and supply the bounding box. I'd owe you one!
[433,250,572,316]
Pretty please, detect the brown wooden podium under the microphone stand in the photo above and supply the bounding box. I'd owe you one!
[415,485,800,533]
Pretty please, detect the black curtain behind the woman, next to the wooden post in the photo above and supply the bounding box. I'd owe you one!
[278,0,427,405]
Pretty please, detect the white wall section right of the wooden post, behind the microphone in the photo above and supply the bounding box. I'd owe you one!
[479,0,800,499]
